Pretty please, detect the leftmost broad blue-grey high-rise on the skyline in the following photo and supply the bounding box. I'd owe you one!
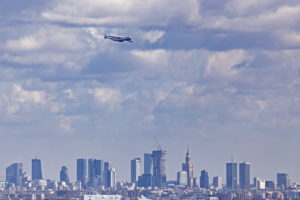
[6,163,24,187]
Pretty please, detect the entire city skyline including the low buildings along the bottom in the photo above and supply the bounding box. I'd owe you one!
[0,148,300,200]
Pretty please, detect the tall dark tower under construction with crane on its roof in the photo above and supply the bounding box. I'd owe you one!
[152,149,167,187]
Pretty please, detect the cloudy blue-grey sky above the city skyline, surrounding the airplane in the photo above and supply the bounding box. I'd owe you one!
[0,0,300,182]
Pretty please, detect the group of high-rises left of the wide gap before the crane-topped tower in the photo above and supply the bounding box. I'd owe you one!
[6,158,117,189]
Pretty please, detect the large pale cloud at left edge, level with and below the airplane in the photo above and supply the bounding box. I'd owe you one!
[0,25,94,71]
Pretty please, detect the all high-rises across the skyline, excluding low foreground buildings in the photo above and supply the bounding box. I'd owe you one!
[6,149,291,190]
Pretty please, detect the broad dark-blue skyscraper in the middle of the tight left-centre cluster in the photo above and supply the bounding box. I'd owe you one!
[88,159,104,186]
